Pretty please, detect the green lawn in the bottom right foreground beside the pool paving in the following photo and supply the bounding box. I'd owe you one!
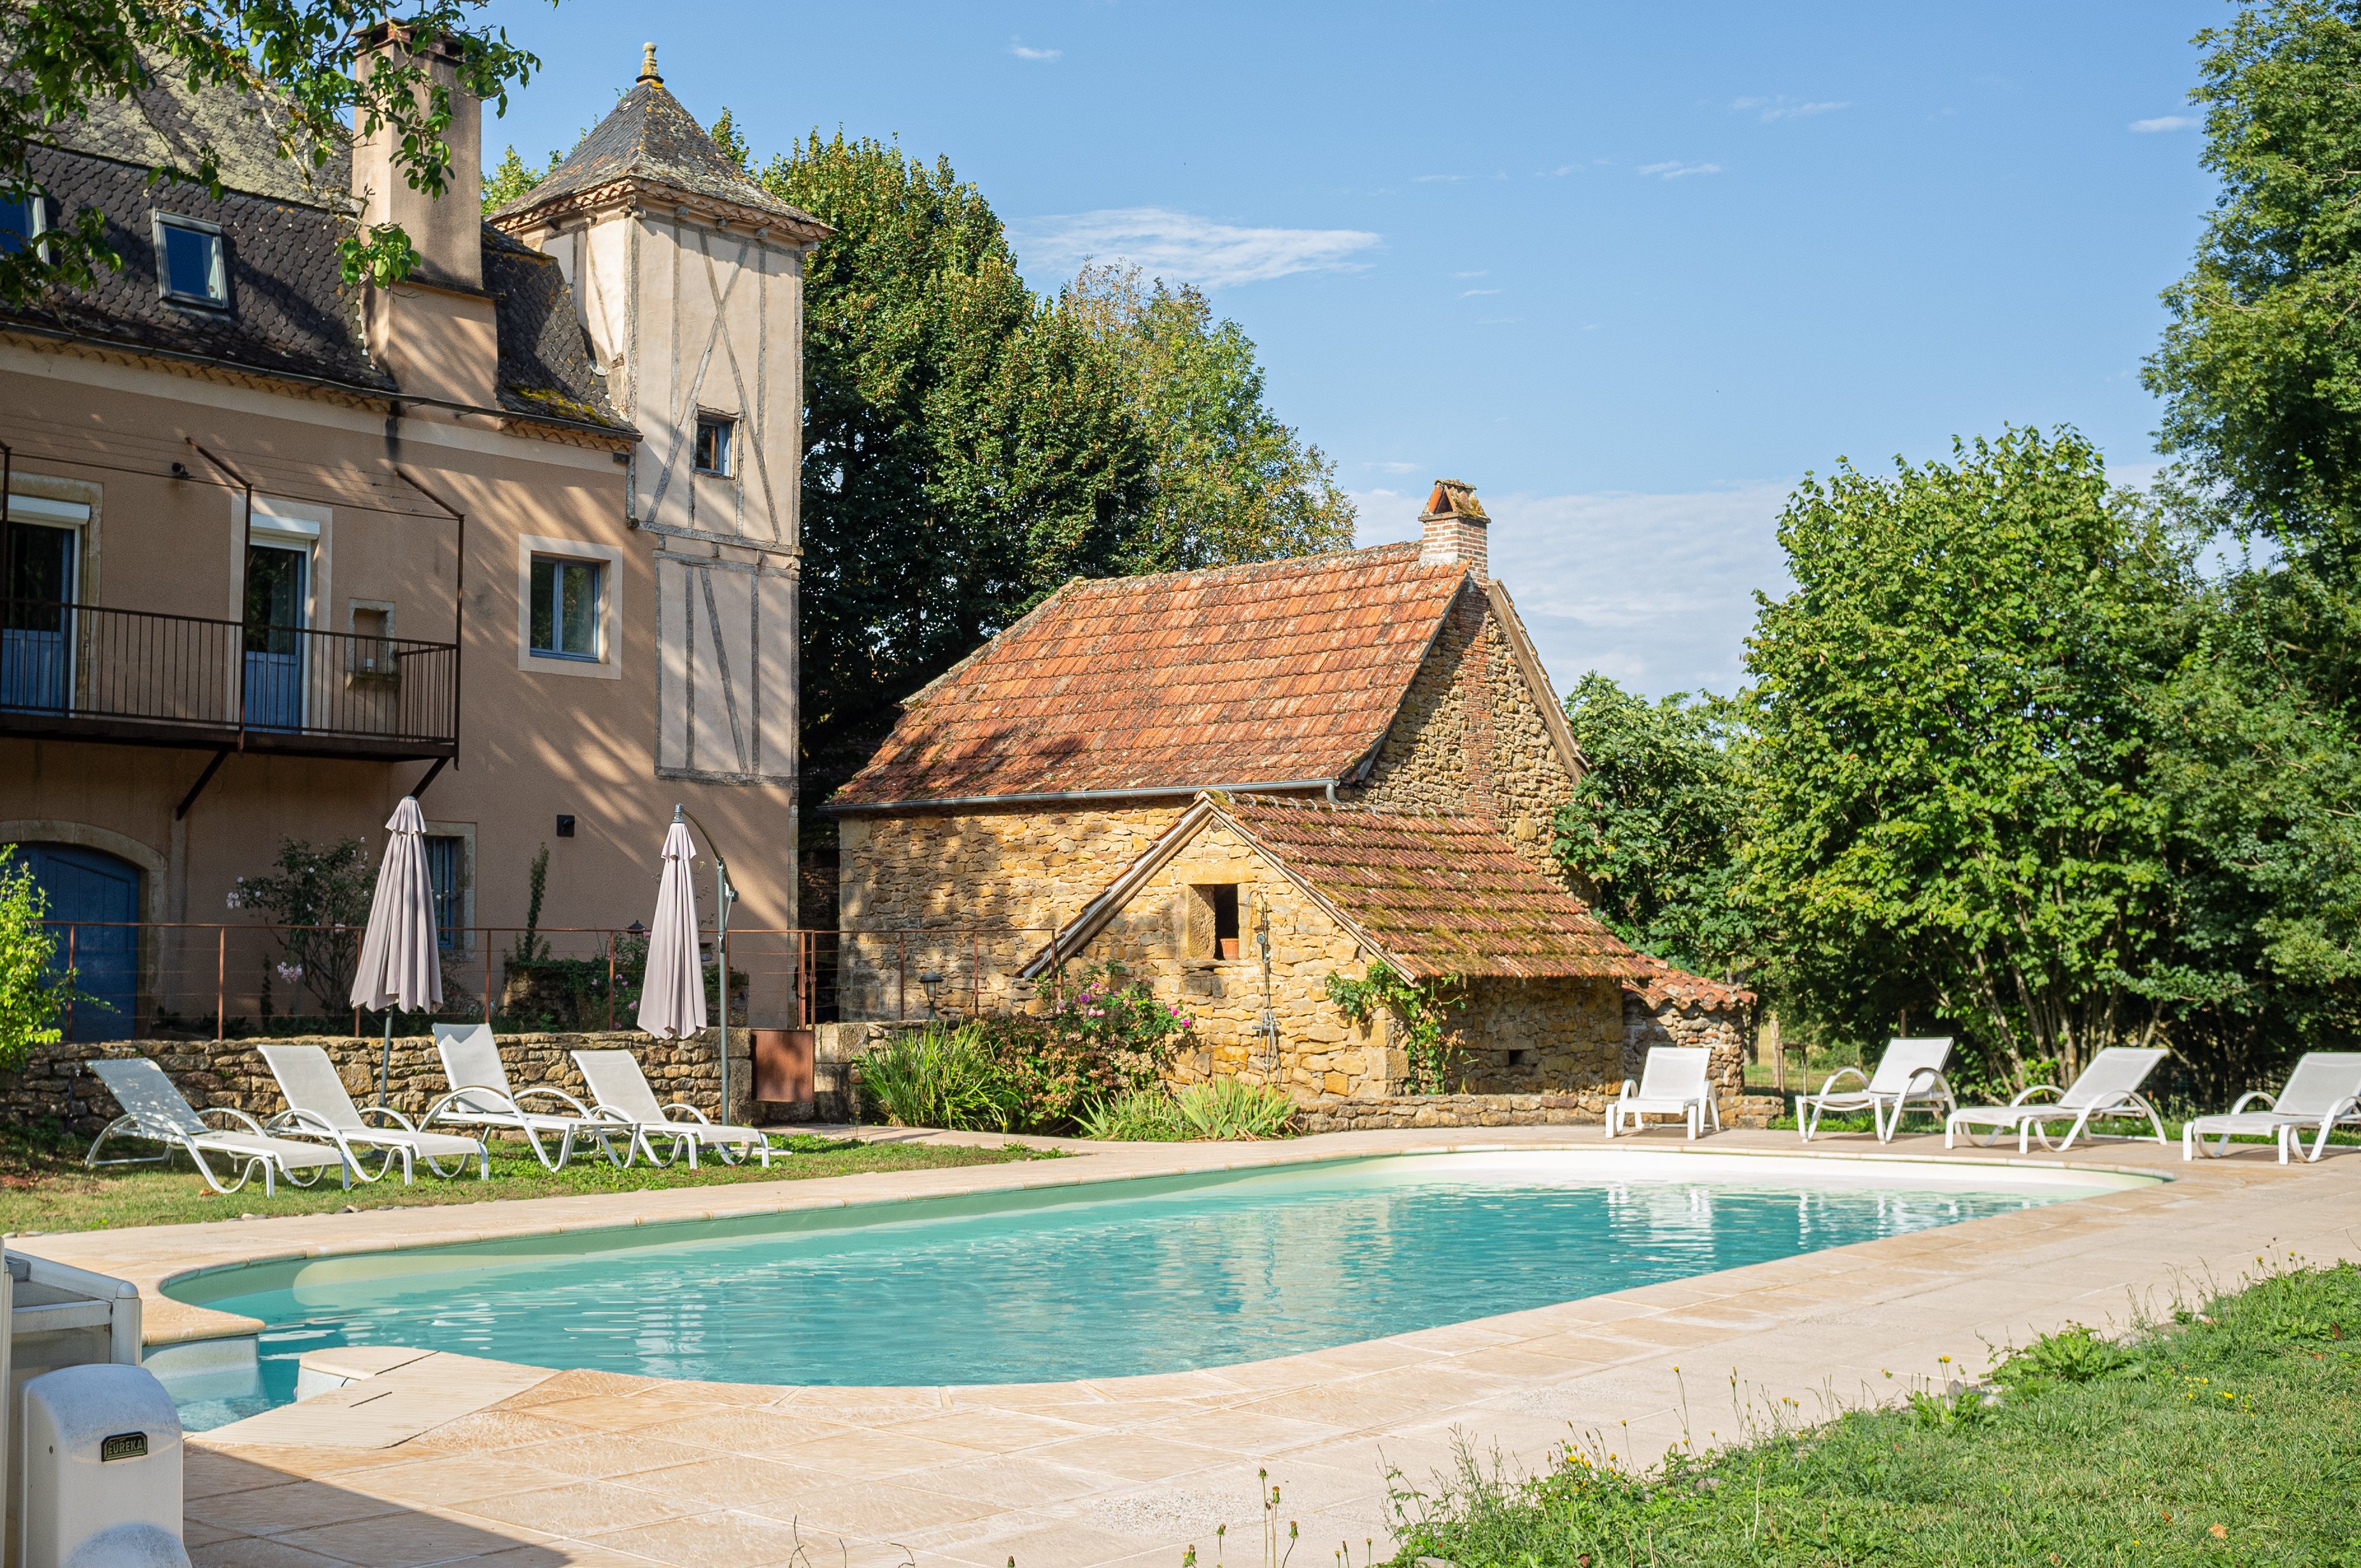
[1398,1263,2361,1568]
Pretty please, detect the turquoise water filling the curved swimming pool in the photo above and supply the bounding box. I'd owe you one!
[152,1150,2127,1429]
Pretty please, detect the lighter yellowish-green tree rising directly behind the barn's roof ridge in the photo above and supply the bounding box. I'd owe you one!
[1058,267,1353,572]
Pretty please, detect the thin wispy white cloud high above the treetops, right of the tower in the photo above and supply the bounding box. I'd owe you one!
[1010,208,1379,288]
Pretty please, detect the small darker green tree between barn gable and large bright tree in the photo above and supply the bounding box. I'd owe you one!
[1554,670,1754,978]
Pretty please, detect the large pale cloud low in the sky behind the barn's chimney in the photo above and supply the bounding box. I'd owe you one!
[1353,470,1792,696]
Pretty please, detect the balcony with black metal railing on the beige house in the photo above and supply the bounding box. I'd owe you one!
[0,600,458,763]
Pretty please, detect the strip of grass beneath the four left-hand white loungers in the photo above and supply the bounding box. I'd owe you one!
[0,1126,1051,1235]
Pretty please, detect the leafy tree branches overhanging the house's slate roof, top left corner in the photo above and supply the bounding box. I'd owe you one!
[0,0,541,305]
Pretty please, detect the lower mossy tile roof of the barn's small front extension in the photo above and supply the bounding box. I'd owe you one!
[1216,796,1643,980]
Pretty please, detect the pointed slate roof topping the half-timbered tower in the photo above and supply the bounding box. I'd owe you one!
[491,45,829,241]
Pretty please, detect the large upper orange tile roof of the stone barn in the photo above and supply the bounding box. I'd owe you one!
[831,543,1466,805]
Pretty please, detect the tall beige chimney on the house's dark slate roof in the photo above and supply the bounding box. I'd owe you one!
[351,29,500,409]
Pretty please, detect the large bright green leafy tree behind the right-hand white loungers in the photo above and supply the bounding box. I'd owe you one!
[1743,430,2187,1075]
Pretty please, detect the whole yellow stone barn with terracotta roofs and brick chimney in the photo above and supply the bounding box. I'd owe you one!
[821,479,1766,1119]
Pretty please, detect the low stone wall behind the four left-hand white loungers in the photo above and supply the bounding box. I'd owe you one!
[0,1029,753,1136]
